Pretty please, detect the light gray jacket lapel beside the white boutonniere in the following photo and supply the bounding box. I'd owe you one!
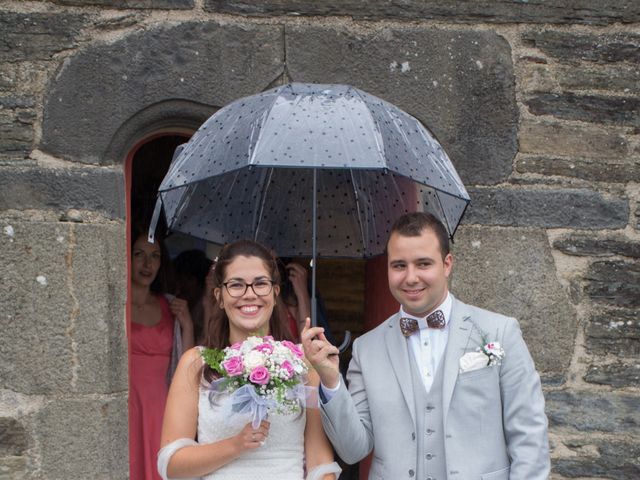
[442,297,472,424]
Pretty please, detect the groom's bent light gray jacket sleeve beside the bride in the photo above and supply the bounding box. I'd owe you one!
[320,340,373,464]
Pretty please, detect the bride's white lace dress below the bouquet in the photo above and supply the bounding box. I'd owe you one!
[198,386,306,480]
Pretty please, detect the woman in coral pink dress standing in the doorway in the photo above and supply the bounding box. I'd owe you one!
[129,229,193,480]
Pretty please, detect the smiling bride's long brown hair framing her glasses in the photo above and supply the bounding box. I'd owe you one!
[202,240,293,378]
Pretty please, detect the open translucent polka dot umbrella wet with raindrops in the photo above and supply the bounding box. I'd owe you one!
[150,83,470,338]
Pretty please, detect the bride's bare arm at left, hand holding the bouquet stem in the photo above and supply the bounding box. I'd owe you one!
[160,348,269,478]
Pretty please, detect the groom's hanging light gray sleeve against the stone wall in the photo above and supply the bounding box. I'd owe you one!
[500,318,551,480]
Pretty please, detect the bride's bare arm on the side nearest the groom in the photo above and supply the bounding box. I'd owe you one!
[304,369,339,480]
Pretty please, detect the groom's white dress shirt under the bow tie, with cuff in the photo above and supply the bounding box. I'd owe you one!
[320,292,453,403]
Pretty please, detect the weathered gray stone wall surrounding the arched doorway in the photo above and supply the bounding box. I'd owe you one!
[0,0,640,479]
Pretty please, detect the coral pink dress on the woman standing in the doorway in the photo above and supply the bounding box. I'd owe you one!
[129,296,174,480]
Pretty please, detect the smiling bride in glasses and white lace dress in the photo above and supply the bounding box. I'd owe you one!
[158,241,340,480]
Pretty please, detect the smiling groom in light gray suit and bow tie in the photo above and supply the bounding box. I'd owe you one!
[302,213,550,480]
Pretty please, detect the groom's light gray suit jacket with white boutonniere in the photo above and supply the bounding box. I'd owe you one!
[321,298,550,480]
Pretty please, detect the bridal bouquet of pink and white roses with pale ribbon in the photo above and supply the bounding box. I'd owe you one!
[201,336,309,428]
